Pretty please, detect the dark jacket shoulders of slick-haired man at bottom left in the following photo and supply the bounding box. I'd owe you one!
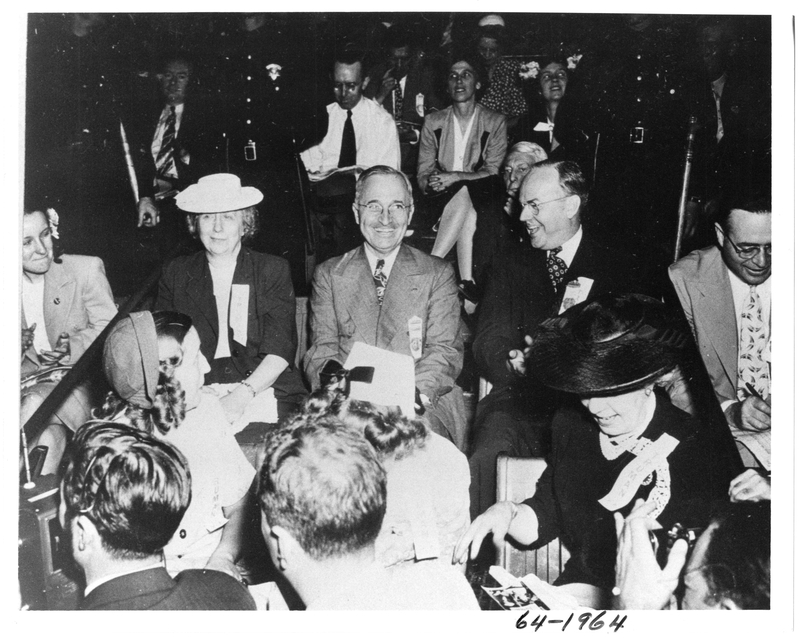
[79,567,256,611]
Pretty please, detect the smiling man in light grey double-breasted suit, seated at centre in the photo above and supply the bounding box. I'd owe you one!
[305,166,467,451]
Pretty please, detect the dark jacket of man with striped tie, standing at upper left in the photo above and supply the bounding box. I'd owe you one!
[125,100,221,198]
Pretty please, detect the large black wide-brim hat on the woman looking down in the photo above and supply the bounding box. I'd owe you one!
[528,294,688,396]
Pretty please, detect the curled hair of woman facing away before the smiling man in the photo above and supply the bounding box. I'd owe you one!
[302,388,428,460]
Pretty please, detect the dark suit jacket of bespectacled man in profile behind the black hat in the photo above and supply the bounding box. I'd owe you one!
[473,229,639,393]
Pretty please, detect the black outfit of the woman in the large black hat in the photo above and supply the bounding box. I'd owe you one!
[525,396,735,588]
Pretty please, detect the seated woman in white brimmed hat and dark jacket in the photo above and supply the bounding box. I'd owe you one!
[156,173,305,430]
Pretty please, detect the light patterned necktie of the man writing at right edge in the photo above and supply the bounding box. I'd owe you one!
[737,286,770,401]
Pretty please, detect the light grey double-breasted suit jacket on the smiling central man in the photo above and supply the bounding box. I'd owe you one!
[305,245,464,448]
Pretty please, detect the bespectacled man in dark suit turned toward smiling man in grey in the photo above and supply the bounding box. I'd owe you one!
[470,160,633,518]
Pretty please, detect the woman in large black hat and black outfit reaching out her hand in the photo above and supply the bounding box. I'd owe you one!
[454,295,733,607]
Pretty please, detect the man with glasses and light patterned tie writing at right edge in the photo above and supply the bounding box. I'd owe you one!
[669,192,772,465]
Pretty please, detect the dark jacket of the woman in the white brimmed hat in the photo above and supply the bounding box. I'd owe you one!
[155,247,306,403]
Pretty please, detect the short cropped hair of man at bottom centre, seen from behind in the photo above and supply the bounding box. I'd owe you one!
[258,415,386,560]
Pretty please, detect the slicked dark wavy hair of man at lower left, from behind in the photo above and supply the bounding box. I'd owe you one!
[62,421,192,560]
